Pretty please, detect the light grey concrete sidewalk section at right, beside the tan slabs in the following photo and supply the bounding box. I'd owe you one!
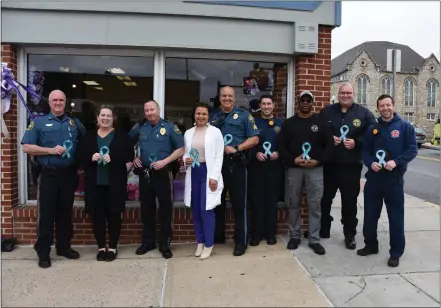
[293,193,440,307]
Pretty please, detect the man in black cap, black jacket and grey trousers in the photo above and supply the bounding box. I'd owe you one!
[278,91,334,255]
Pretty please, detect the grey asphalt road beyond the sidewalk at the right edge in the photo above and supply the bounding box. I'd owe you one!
[362,149,441,205]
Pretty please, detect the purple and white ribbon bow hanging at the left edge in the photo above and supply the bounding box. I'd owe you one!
[1,62,40,138]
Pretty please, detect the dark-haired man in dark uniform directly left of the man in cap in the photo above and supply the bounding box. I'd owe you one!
[249,95,283,246]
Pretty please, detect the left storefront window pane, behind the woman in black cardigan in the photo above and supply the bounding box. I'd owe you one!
[27,54,153,200]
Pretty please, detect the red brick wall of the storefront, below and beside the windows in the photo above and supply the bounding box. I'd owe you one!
[2,27,332,245]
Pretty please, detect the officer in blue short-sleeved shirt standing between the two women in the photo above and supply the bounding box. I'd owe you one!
[129,100,184,259]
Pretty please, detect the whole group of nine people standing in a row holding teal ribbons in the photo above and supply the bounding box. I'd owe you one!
[22,84,416,268]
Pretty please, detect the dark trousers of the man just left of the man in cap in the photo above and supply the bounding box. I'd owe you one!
[249,161,282,240]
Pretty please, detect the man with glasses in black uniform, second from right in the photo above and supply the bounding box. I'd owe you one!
[320,83,376,249]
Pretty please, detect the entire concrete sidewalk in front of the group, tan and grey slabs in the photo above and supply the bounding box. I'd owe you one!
[2,194,440,307]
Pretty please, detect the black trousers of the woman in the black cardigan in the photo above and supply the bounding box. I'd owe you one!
[92,185,121,249]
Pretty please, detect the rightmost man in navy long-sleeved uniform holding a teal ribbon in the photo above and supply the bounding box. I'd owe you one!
[357,95,418,267]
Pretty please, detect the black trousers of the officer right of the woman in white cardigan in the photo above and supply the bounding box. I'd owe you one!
[214,155,248,246]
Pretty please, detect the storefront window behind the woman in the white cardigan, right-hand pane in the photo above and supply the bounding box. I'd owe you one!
[164,58,287,201]
